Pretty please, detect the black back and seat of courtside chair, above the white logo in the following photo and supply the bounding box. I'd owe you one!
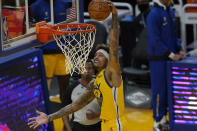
[123,29,150,86]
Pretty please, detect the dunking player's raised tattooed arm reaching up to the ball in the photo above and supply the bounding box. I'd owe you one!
[106,2,121,87]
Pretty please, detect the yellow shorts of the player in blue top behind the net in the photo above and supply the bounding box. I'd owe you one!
[44,54,68,78]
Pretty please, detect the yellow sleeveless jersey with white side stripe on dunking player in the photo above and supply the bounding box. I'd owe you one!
[94,69,124,120]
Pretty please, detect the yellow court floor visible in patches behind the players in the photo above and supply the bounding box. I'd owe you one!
[51,98,153,131]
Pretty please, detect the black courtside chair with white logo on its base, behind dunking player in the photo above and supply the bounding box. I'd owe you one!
[123,28,152,109]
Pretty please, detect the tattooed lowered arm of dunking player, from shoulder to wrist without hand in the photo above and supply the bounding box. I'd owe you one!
[48,87,95,121]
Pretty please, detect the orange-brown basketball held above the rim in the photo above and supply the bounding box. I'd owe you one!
[88,0,111,21]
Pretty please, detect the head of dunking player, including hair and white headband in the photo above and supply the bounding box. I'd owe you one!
[94,44,109,71]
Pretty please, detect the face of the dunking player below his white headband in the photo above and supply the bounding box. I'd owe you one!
[94,52,108,70]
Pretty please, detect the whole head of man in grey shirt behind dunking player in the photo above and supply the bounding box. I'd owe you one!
[81,59,95,81]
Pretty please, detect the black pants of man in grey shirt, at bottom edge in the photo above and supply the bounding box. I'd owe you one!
[72,122,101,131]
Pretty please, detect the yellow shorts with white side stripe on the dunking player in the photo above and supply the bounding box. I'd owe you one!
[101,116,129,131]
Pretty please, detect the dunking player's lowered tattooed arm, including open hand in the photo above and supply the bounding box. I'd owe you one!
[28,84,95,129]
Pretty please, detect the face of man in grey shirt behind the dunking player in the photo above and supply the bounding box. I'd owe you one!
[81,62,94,80]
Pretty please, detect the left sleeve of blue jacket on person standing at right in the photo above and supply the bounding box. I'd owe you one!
[147,13,170,56]
